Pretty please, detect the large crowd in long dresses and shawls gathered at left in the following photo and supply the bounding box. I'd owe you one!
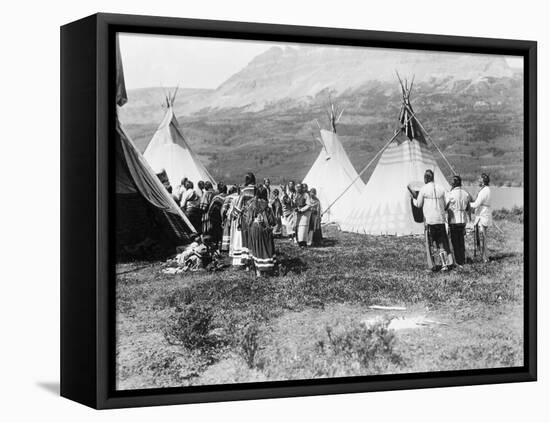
[169,172,322,276]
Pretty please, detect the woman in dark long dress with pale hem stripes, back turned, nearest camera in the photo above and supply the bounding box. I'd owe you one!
[243,186,276,276]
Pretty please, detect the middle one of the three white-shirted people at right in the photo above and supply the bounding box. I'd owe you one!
[446,175,472,266]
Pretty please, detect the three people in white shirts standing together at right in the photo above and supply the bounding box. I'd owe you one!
[411,169,492,270]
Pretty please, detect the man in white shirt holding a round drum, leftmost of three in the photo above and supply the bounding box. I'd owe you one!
[414,169,453,271]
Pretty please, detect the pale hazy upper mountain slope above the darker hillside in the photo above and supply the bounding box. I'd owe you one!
[119,47,515,121]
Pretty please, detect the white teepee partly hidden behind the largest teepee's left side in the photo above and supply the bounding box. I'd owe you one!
[303,104,365,225]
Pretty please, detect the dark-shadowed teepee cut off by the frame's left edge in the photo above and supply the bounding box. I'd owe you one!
[113,40,195,256]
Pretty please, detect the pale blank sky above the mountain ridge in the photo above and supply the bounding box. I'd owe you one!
[119,33,522,89]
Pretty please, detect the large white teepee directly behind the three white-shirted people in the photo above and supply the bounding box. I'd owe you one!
[341,79,450,235]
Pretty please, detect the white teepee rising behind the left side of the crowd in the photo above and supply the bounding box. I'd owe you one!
[143,93,216,188]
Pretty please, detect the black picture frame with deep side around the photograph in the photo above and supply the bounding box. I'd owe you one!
[61,13,537,409]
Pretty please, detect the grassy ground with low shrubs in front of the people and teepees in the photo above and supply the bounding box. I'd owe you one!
[117,217,523,389]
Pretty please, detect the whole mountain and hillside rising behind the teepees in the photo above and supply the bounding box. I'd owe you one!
[117,47,523,185]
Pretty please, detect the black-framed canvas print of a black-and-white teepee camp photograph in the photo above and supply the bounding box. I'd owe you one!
[61,14,537,408]
